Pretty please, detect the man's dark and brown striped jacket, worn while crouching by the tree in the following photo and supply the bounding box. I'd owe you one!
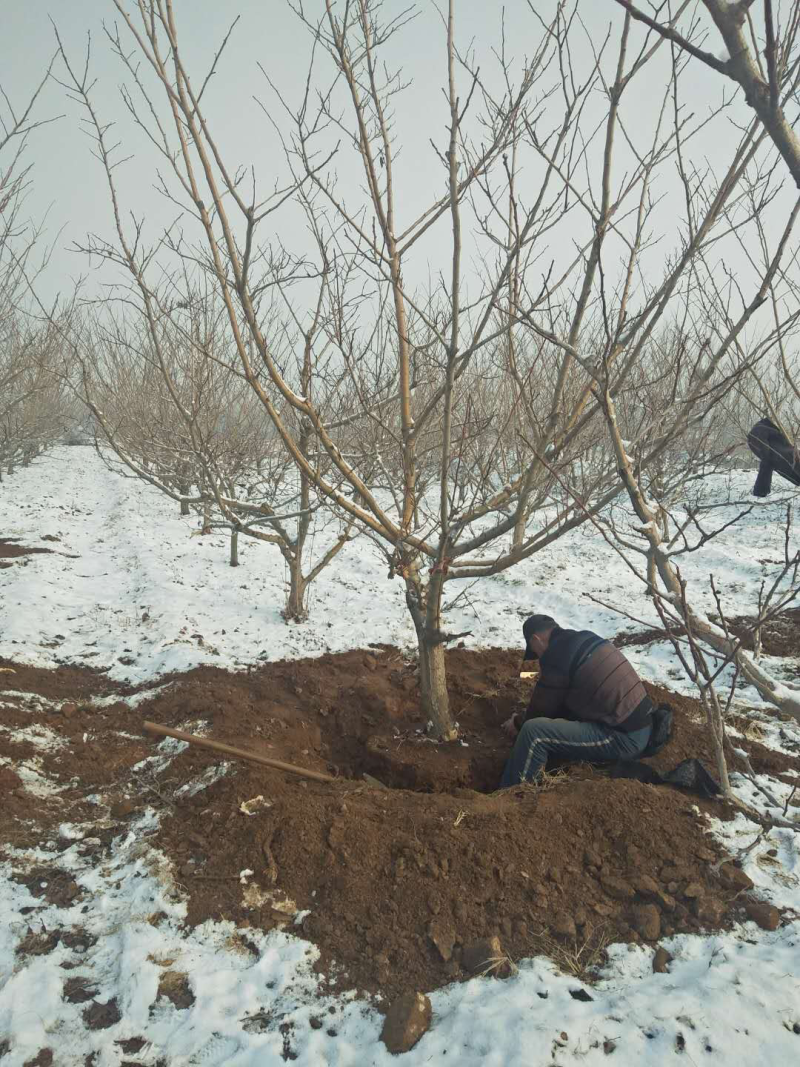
[523,626,653,733]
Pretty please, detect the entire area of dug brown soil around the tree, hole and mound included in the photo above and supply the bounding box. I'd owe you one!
[0,648,800,996]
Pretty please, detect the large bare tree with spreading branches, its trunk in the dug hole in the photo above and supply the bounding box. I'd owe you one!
[54,0,800,738]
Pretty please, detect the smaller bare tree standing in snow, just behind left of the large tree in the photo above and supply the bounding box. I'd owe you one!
[65,297,352,621]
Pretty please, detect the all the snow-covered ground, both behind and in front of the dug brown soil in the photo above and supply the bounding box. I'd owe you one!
[0,448,800,1067]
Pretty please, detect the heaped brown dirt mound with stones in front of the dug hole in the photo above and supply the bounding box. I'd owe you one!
[160,757,736,994]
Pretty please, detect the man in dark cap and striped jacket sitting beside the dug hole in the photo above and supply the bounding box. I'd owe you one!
[500,615,654,789]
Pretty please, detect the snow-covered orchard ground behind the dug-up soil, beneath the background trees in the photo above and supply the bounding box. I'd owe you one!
[0,447,797,687]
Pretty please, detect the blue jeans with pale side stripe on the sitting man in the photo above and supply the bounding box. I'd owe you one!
[500,719,652,790]
